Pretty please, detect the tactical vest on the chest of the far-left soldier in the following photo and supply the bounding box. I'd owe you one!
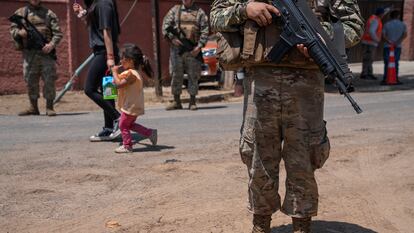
[18,6,52,47]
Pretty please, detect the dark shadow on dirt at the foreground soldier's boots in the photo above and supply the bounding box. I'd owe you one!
[271,221,378,233]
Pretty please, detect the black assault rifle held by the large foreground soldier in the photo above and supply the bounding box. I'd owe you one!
[267,0,362,113]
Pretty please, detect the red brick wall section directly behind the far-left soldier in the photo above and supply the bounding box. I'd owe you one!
[0,0,72,94]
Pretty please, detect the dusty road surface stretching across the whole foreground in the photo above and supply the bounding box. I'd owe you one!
[0,91,414,233]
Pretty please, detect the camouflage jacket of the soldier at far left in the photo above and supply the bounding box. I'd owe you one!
[10,4,63,49]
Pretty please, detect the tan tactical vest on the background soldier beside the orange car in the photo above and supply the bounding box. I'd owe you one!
[175,5,200,43]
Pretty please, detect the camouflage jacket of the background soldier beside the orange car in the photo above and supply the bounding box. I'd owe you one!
[162,5,209,48]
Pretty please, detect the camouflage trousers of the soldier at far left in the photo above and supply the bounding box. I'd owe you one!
[23,50,57,100]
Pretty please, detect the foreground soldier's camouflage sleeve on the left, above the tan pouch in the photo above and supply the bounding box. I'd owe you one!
[210,0,247,32]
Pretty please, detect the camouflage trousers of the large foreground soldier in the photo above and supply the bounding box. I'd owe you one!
[240,67,330,218]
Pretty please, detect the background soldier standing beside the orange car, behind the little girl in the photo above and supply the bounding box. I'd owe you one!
[162,0,209,110]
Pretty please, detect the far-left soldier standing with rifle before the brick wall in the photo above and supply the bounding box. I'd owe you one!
[10,0,63,116]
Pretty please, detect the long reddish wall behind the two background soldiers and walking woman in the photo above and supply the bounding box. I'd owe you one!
[0,0,211,94]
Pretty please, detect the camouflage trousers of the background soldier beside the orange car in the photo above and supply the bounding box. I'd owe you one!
[170,48,201,95]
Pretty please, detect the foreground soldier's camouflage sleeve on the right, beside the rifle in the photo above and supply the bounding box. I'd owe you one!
[332,0,364,48]
